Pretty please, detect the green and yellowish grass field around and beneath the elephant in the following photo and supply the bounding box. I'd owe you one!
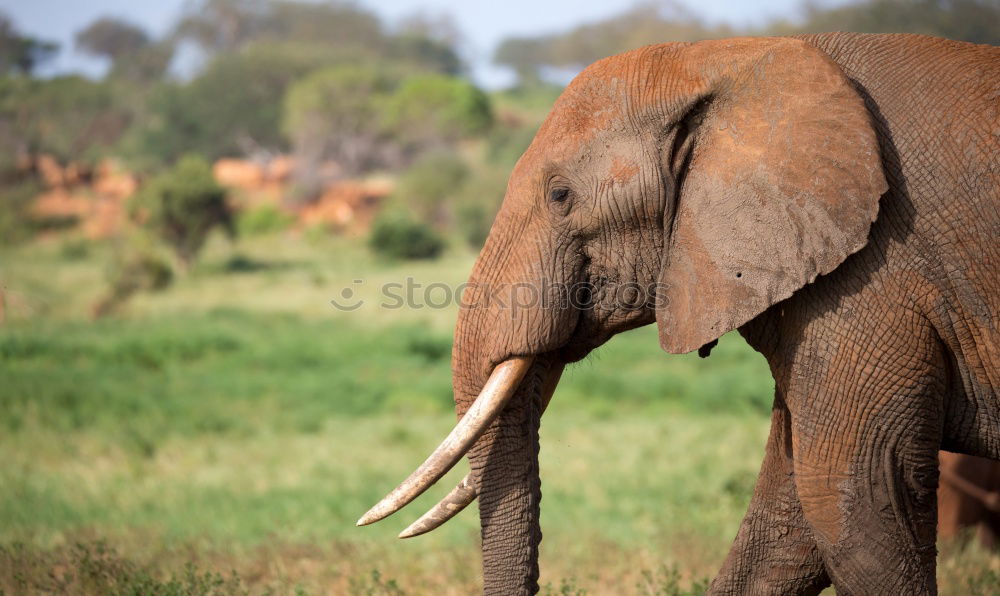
[0,234,1000,594]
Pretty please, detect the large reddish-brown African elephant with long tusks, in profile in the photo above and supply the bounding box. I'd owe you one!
[359,33,1000,594]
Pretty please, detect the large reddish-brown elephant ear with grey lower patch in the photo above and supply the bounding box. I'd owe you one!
[656,38,887,353]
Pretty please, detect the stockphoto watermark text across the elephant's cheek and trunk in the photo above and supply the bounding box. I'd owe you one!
[330,277,666,316]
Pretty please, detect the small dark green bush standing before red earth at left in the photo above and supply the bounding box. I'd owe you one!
[136,155,234,268]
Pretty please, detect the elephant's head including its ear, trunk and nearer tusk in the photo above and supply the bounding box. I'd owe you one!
[359,38,887,593]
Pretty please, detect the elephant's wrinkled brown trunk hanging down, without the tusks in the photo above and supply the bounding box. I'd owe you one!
[446,198,578,594]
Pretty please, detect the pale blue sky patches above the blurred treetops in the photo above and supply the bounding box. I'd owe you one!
[0,0,844,88]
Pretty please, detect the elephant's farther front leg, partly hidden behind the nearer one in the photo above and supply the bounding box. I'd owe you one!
[710,391,830,594]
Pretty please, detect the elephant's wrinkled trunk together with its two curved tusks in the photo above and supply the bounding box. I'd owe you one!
[359,190,579,594]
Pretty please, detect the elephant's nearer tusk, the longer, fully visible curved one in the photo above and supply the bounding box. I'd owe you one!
[358,356,534,526]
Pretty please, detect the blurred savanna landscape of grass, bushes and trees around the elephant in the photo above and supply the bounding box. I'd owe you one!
[0,0,1000,594]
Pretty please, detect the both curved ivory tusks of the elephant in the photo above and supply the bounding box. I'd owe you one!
[357,353,564,538]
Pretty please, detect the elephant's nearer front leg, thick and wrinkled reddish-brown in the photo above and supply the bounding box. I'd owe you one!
[789,344,943,594]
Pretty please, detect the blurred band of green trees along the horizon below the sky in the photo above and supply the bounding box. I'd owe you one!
[0,0,1000,264]
